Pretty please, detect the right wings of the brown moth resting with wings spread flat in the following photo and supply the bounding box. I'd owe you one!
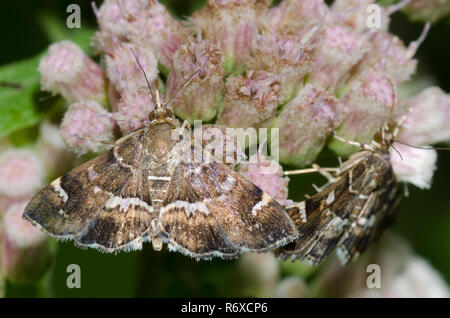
[159,163,297,258]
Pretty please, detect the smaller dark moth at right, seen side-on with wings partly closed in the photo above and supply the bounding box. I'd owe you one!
[275,124,402,265]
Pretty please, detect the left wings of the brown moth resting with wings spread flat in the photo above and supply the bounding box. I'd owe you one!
[24,130,155,252]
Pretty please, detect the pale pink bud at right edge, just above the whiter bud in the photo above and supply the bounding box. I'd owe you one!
[398,87,450,145]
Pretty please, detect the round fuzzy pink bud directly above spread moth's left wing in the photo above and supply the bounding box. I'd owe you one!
[60,101,114,155]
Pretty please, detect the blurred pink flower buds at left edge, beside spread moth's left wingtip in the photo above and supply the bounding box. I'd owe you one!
[0,145,59,285]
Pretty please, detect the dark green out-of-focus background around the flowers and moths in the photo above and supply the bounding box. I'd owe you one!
[0,0,450,297]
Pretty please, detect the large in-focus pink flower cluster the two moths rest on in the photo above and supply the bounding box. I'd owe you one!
[39,0,450,207]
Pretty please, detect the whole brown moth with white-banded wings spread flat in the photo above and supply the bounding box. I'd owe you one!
[24,107,297,259]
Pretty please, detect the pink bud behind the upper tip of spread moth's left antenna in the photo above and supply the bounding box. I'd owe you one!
[105,39,158,94]
